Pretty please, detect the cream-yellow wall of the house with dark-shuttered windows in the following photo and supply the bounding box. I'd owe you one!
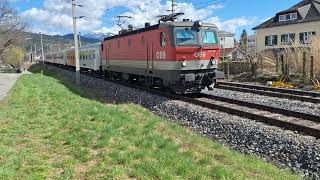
[256,21,320,52]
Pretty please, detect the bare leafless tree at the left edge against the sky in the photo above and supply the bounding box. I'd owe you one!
[0,0,26,58]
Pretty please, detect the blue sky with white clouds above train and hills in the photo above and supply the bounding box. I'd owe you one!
[9,0,299,37]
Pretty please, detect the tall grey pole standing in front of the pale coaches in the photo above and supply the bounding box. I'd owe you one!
[72,0,80,85]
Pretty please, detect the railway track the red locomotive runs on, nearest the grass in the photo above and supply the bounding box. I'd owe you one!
[48,64,320,138]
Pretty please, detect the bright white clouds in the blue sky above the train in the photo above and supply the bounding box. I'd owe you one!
[21,0,254,34]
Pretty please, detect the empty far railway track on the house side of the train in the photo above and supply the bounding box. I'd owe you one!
[215,82,320,103]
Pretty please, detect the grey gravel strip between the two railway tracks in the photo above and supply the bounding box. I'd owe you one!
[203,89,320,115]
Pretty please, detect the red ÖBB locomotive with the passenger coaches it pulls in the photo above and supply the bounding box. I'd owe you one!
[46,16,223,94]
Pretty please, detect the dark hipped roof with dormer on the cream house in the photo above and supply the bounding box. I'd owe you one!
[253,0,320,30]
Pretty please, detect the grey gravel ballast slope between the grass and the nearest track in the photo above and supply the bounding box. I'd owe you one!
[47,66,320,179]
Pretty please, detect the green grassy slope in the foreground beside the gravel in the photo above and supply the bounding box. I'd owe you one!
[0,70,299,179]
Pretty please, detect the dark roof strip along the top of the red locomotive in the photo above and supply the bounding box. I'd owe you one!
[104,21,217,41]
